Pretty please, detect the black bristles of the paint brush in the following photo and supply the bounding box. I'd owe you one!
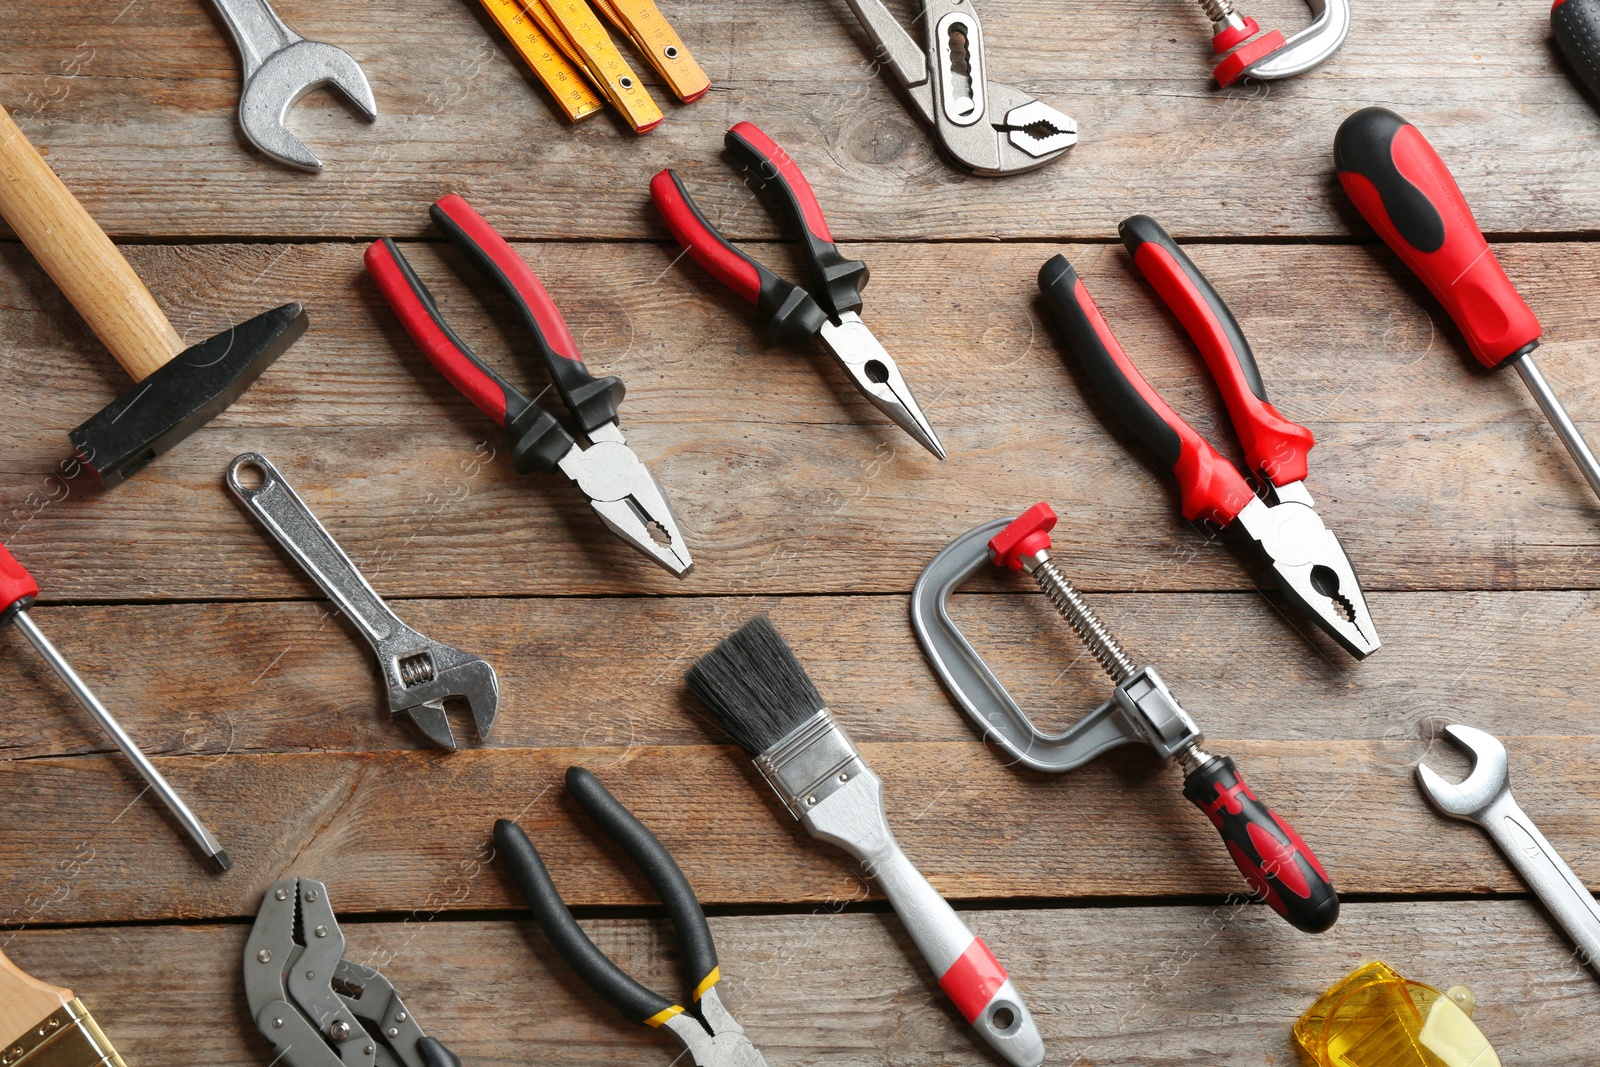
[688,614,826,757]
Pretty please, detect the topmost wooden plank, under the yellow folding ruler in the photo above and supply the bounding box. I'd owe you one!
[0,0,1600,238]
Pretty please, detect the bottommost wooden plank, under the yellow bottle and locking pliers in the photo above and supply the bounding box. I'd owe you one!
[6,908,1600,1067]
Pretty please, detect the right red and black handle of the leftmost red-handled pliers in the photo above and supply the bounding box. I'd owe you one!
[427,194,627,434]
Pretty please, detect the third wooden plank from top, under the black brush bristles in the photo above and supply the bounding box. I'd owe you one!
[9,582,1600,760]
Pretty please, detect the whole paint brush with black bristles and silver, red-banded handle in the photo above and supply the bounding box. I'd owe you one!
[688,616,1045,1067]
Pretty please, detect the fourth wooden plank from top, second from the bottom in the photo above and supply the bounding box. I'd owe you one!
[0,739,1600,925]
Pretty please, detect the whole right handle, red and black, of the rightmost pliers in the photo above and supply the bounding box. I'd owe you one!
[1117,214,1317,485]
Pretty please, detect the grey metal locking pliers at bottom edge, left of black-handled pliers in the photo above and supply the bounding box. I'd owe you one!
[245,878,461,1067]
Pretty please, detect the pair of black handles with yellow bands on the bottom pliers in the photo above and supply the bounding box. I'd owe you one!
[494,766,722,1027]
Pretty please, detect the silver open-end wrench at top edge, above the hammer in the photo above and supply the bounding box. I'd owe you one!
[213,0,378,171]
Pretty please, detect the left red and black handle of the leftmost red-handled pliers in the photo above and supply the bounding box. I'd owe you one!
[363,237,587,474]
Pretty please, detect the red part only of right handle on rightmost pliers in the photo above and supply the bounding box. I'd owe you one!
[1133,242,1317,485]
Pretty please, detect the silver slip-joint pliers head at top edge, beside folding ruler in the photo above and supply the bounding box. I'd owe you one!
[848,0,1078,176]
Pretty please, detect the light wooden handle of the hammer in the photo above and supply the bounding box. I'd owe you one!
[0,107,184,382]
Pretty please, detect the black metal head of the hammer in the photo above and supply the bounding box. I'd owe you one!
[72,304,307,486]
